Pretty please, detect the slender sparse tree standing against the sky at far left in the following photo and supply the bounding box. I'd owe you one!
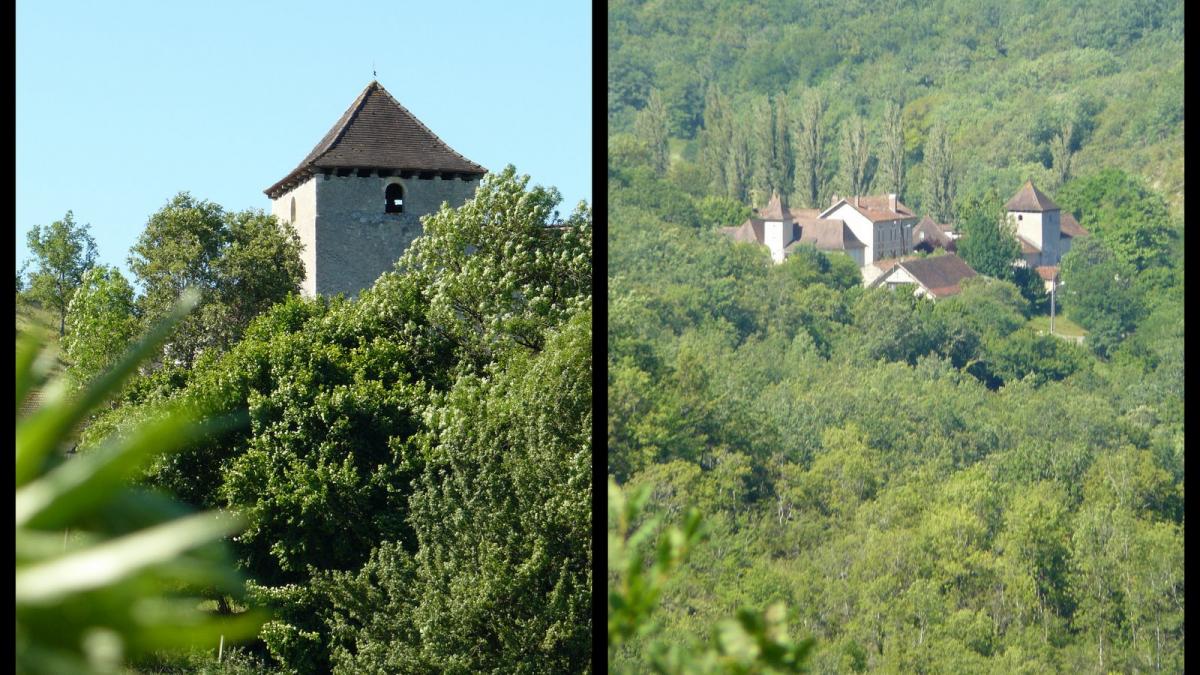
[26,211,97,336]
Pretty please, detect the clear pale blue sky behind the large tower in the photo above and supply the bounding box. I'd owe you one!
[16,0,593,281]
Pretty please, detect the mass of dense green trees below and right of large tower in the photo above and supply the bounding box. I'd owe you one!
[83,167,592,673]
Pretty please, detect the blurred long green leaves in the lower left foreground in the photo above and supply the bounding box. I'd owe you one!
[16,295,263,673]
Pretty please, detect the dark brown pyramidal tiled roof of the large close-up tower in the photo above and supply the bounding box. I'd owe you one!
[264,80,487,199]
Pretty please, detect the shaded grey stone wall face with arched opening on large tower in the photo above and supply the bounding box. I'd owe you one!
[309,175,479,295]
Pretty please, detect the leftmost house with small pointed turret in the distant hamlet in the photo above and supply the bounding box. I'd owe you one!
[720,192,866,267]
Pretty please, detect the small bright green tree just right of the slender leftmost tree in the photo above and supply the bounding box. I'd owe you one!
[62,265,138,384]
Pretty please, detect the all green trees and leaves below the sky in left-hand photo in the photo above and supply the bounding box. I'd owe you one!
[17,166,593,673]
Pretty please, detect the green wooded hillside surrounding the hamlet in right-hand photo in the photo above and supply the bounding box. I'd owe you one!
[606,0,1184,673]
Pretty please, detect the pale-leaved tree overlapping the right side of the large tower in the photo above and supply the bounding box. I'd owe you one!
[396,166,592,366]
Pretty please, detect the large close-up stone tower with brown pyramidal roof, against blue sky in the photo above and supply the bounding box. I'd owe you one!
[264,80,487,297]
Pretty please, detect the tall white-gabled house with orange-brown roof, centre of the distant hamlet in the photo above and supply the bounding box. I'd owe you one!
[818,195,917,267]
